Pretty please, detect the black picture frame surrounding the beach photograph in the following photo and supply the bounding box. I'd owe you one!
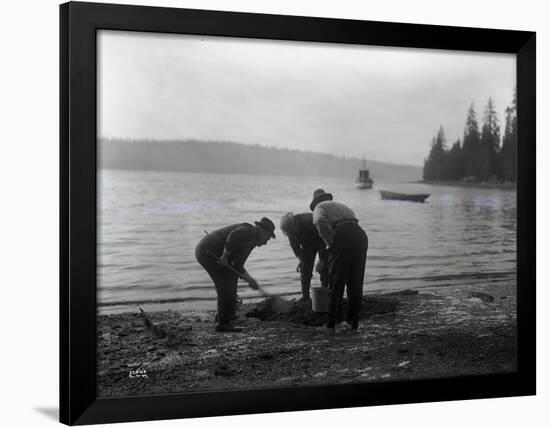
[60,2,536,425]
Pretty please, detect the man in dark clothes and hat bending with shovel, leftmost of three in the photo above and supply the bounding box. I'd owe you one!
[195,217,275,332]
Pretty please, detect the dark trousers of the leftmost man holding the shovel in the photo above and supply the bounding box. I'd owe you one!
[195,239,239,323]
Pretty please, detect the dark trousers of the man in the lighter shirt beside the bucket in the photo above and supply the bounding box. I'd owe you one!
[328,223,369,326]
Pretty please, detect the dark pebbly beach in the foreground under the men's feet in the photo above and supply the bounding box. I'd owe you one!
[97,283,517,396]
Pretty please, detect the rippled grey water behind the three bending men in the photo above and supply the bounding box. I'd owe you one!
[98,170,516,311]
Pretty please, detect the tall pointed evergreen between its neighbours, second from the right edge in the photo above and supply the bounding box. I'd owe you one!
[478,98,500,181]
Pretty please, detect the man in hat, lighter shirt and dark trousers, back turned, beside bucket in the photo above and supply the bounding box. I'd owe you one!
[309,189,368,330]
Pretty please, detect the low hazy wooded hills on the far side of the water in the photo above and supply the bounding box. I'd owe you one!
[98,139,422,181]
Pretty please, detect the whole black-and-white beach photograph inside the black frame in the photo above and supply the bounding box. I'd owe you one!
[97,30,522,397]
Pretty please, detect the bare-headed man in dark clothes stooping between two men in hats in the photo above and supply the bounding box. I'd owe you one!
[281,212,328,300]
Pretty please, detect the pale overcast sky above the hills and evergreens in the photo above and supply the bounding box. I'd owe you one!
[98,31,515,165]
